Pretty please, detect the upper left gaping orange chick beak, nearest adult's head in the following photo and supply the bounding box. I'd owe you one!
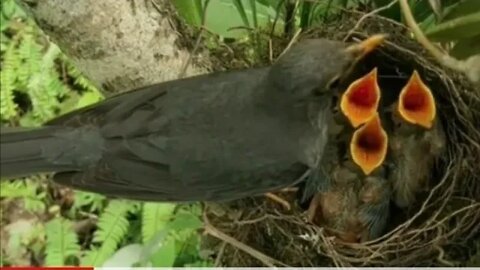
[340,68,381,128]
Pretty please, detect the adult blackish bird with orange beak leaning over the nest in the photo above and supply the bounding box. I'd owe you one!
[0,35,384,201]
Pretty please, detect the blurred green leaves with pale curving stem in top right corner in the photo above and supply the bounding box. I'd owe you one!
[399,0,480,83]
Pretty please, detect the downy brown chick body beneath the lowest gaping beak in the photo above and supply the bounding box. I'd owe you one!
[307,161,391,243]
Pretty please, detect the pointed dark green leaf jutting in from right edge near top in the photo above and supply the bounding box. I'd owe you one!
[426,12,480,42]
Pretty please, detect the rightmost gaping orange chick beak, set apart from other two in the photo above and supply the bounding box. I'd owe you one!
[397,71,437,129]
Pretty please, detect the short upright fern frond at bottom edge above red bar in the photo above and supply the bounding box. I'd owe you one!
[45,217,80,266]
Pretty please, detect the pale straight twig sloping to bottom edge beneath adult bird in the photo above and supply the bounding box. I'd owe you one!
[203,211,288,267]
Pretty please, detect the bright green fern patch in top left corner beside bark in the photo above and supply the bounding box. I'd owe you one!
[0,0,102,126]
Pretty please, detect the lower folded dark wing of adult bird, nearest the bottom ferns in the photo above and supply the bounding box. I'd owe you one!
[54,157,308,202]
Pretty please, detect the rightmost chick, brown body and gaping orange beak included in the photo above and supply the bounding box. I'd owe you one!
[389,71,445,208]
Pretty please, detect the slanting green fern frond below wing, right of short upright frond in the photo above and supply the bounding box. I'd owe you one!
[82,200,130,266]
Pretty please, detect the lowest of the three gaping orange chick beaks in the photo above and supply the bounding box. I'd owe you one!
[350,113,388,175]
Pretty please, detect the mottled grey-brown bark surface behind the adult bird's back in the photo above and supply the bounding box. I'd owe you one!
[19,0,208,94]
